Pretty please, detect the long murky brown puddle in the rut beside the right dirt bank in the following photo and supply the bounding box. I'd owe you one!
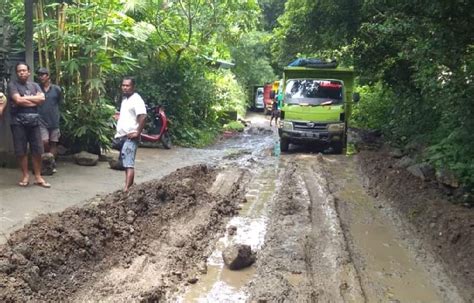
[330,161,443,302]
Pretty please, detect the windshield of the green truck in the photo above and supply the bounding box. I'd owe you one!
[285,79,342,105]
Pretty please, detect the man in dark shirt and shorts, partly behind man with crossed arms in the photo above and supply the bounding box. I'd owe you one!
[36,67,63,167]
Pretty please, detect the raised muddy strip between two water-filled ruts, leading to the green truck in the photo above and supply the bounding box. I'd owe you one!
[250,155,365,302]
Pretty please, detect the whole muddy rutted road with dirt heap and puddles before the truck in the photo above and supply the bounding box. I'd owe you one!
[0,114,474,302]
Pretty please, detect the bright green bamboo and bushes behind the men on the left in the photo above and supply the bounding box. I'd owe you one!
[6,0,262,152]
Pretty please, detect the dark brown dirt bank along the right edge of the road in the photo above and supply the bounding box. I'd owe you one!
[358,147,474,302]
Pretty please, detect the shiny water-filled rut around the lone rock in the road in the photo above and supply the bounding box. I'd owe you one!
[177,167,277,302]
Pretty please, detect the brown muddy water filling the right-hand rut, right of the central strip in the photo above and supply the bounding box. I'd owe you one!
[325,156,462,302]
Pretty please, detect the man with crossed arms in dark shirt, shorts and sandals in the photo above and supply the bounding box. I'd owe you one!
[8,62,51,188]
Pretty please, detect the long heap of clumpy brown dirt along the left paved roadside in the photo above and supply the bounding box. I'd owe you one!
[0,165,243,302]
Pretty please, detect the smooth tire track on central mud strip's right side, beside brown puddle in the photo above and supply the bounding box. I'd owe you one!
[301,155,366,302]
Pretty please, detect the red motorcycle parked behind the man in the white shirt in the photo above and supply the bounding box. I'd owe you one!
[114,105,171,149]
